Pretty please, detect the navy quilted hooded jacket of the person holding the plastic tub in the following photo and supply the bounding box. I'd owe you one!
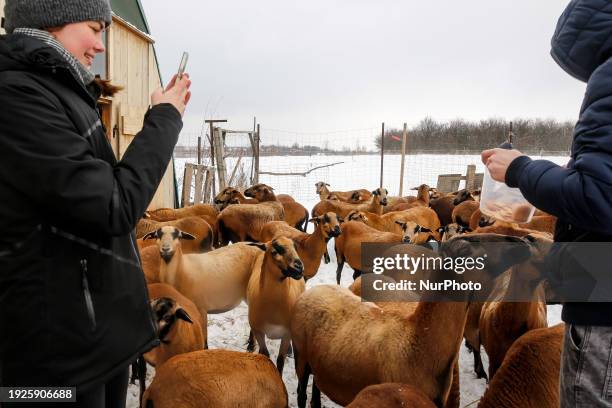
[506,0,612,326]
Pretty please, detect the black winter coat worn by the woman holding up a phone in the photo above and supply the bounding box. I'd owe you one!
[0,34,182,389]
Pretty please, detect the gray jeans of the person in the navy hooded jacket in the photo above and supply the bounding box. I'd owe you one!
[560,324,612,408]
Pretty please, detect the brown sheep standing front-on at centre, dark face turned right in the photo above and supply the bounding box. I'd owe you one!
[247,236,306,375]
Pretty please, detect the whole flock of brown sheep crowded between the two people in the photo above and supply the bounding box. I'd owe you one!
[133,182,563,408]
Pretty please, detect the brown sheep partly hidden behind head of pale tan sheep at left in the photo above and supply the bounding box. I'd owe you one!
[136,216,215,250]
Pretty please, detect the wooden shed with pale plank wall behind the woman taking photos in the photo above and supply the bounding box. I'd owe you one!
[0,0,178,209]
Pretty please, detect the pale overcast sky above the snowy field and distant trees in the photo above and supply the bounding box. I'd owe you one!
[141,0,585,147]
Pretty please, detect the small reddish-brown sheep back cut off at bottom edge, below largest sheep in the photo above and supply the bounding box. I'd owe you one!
[346,383,436,408]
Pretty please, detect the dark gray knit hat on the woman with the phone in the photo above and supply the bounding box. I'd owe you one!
[4,0,112,34]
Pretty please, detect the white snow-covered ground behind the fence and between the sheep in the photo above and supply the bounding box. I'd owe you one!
[128,155,568,408]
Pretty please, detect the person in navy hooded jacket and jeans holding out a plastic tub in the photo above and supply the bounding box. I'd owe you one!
[482,0,612,407]
